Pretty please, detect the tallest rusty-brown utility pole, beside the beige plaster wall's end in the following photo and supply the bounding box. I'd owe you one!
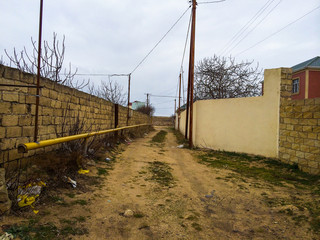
[186,0,197,148]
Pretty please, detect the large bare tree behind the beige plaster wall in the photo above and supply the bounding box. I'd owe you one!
[194,55,262,99]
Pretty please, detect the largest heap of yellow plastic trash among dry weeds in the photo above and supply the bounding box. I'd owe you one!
[17,181,46,207]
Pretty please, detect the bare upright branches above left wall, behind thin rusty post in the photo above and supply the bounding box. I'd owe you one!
[5,33,89,89]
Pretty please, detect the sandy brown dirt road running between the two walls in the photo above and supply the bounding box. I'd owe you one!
[72,128,311,239]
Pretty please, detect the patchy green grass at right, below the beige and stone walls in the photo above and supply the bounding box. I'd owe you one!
[197,151,320,233]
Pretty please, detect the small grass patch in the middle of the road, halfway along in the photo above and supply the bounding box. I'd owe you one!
[149,161,174,186]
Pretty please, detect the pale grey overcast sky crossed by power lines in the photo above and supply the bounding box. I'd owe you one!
[0,0,320,116]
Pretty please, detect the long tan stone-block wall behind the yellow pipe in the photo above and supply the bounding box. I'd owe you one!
[0,65,150,162]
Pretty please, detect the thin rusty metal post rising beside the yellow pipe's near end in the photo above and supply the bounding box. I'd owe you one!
[34,0,43,142]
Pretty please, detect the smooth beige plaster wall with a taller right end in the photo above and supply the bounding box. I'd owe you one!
[180,68,283,157]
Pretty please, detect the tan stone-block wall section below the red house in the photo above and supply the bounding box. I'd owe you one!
[279,69,320,174]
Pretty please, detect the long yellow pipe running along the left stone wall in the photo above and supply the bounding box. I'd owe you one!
[18,124,150,153]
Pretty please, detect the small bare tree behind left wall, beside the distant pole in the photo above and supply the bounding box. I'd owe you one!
[94,78,127,106]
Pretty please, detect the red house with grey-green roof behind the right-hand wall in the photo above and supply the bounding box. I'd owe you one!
[292,56,320,99]
